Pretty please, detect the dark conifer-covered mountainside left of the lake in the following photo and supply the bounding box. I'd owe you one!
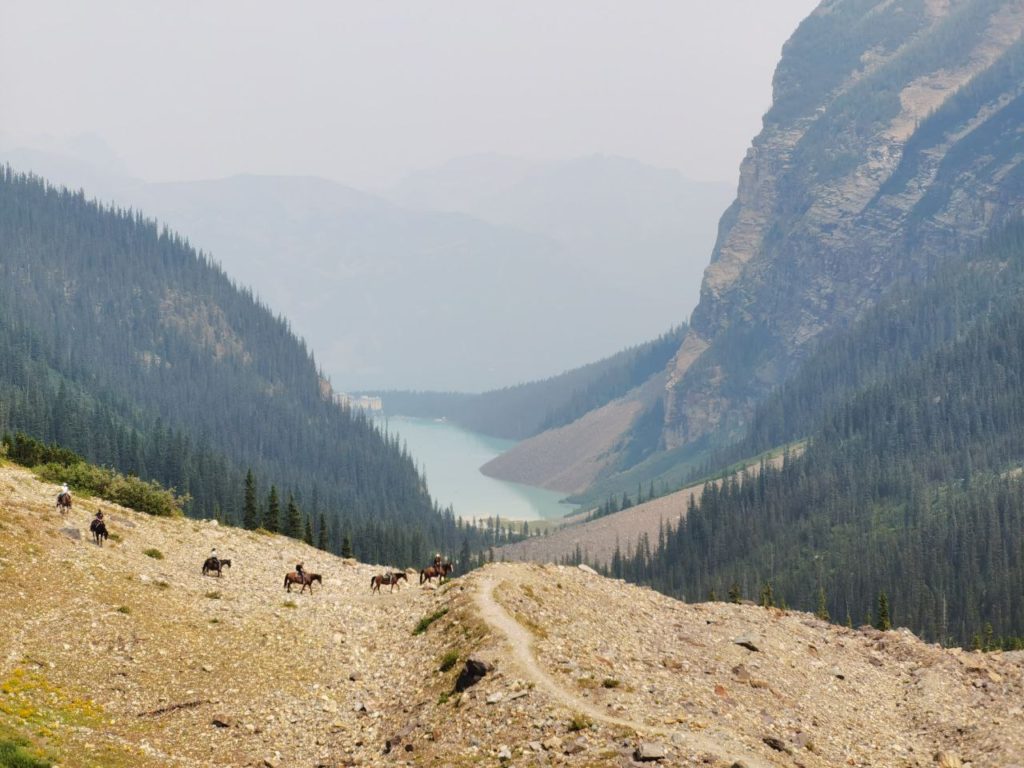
[0,168,472,563]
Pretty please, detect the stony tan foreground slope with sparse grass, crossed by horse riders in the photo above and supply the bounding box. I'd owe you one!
[0,467,1024,768]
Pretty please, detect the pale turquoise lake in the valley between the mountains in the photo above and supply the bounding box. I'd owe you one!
[382,416,573,520]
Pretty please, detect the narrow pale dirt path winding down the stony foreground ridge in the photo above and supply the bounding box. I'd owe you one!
[476,579,771,768]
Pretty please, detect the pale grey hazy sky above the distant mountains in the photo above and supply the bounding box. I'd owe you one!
[0,0,817,186]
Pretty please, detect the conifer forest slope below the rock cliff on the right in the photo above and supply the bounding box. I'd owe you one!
[609,223,1024,644]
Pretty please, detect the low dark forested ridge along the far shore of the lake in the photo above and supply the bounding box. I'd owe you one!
[383,324,686,440]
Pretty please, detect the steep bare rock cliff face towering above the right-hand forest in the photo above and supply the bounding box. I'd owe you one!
[487,0,1024,499]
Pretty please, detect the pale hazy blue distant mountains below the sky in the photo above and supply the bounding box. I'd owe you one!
[0,151,730,391]
